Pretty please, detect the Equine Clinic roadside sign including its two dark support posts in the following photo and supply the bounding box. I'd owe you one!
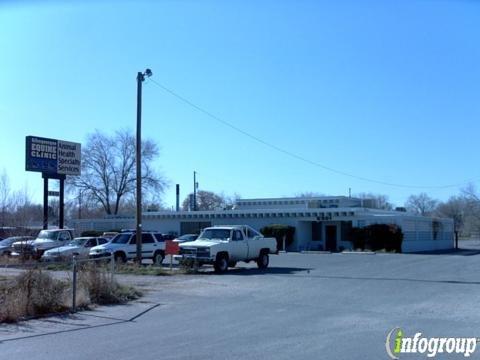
[25,136,81,229]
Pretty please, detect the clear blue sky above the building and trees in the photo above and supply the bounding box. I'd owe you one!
[0,0,480,206]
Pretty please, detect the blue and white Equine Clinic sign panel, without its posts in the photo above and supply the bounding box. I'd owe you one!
[25,136,81,175]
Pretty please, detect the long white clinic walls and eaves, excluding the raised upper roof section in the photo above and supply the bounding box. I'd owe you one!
[72,208,454,252]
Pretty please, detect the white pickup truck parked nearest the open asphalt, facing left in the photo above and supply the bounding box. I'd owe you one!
[174,225,277,273]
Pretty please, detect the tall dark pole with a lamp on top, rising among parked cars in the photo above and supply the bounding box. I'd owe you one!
[135,69,152,265]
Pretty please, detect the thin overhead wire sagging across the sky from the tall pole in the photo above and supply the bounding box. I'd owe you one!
[148,78,479,189]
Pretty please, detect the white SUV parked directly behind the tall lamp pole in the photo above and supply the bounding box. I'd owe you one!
[89,231,165,264]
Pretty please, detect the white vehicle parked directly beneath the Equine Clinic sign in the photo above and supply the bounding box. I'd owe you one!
[12,229,74,259]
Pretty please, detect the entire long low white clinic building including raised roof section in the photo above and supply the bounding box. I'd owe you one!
[74,196,454,252]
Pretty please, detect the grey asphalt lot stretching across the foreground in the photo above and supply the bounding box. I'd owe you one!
[0,251,480,360]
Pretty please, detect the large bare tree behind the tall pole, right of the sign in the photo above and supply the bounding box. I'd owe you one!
[70,130,166,215]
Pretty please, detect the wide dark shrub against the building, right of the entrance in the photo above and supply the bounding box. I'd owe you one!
[352,224,403,253]
